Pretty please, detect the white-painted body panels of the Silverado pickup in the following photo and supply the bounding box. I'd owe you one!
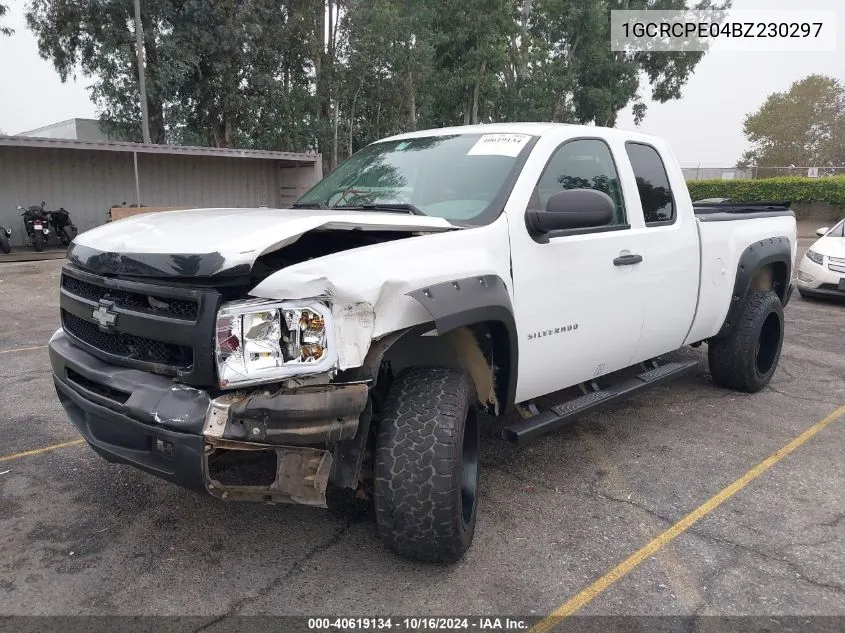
[72,124,796,402]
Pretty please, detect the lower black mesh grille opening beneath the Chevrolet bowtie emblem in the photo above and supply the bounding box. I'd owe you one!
[62,310,194,369]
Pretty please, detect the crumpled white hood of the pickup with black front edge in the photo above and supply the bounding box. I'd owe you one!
[68,209,458,276]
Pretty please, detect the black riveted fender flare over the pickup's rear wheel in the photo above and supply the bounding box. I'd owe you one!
[712,236,792,339]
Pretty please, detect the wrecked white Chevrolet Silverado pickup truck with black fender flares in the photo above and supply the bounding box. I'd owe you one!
[49,123,796,561]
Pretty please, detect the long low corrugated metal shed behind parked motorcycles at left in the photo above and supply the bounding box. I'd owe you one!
[0,136,322,247]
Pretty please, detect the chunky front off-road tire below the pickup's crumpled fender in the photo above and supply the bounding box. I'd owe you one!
[375,367,479,562]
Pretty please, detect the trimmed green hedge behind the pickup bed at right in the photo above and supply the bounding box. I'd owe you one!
[687,176,845,207]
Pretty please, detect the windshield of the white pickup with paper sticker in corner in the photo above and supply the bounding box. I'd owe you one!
[297,134,532,221]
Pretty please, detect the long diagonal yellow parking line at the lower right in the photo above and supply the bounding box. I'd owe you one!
[529,405,845,633]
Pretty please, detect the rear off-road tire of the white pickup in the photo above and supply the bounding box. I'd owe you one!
[707,290,783,393]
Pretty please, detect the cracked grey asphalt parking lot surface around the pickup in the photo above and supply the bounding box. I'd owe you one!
[0,239,845,622]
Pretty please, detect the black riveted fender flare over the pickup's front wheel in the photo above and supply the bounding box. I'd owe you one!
[407,275,519,413]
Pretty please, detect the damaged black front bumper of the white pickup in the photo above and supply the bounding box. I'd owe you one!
[49,330,369,505]
